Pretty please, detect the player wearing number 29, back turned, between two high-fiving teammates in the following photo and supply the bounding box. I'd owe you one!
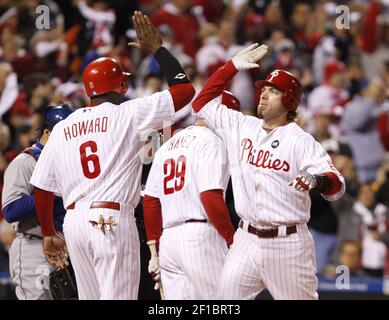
[143,92,239,300]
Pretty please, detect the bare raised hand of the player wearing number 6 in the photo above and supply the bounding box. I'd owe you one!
[128,11,162,54]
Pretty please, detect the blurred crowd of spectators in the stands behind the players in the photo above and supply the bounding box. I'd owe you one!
[0,0,389,298]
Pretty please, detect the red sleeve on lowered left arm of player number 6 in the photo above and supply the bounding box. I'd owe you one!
[34,188,56,237]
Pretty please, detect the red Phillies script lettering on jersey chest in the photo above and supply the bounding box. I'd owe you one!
[240,138,290,172]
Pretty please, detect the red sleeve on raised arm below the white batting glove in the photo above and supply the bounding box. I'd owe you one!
[192,60,238,112]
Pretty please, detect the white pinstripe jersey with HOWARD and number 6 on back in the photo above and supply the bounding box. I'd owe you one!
[30,90,174,207]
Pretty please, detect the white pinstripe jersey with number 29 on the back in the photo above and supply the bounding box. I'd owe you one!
[145,126,229,228]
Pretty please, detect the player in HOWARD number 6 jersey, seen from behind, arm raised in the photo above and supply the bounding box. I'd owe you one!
[31,11,194,299]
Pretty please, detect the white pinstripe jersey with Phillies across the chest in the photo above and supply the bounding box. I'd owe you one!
[198,97,345,227]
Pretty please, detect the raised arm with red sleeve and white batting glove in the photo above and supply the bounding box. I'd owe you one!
[192,43,267,112]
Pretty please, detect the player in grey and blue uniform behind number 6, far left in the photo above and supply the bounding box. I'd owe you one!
[2,106,72,300]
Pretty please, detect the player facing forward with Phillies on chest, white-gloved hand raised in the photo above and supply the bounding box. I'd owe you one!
[193,44,345,299]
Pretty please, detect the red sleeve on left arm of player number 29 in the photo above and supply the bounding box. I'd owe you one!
[143,195,162,243]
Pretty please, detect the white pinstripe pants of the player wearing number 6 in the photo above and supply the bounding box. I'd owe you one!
[63,203,140,300]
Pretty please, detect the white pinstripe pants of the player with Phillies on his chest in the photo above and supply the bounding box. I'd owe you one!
[218,224,318,300]
